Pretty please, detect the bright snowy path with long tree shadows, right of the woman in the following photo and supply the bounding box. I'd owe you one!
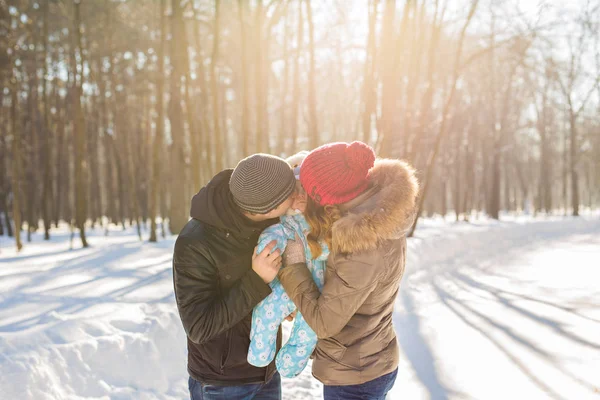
[392,220,600,399]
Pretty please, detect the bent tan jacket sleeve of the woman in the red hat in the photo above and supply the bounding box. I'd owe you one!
[279,254,377,339]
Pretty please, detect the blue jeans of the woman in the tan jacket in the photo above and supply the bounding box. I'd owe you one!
[323,369,398,400]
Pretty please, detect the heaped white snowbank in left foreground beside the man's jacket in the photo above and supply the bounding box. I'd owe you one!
[0,305,186,399]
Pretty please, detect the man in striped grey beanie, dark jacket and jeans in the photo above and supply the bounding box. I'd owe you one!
[173,154,296,400]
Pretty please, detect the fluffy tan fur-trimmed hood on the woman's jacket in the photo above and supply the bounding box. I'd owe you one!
[332,159,419,254]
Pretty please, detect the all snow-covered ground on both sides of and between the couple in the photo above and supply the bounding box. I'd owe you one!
[0,216,600,400]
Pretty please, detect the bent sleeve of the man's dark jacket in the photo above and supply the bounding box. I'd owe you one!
[173,238,271,344]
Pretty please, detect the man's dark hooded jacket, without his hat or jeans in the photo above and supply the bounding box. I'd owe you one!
[173,170,281,385]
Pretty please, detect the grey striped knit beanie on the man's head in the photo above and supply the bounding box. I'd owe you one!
[229,154,296,214]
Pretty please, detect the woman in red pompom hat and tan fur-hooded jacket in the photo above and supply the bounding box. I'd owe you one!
[279,142,418,400]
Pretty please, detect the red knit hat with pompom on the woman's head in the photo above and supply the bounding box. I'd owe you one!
[300,142,375,206]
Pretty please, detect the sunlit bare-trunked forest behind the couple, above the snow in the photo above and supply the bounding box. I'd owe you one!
[0,0,600,247]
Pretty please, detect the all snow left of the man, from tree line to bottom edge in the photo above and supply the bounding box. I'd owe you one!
[0,231,187,399]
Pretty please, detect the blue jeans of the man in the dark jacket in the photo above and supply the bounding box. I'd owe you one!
[188,372,281,400]
